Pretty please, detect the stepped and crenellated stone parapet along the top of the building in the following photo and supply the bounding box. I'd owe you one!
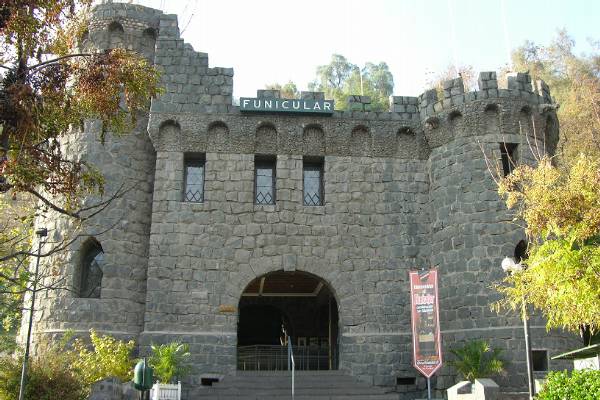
[89,2,556,154]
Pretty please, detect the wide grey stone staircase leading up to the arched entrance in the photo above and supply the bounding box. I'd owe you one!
[185,371,399,400]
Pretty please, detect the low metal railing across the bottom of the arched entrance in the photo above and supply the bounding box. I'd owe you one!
[237,341,336,371]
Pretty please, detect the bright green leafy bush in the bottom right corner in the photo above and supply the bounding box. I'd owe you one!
[536,370,600,400]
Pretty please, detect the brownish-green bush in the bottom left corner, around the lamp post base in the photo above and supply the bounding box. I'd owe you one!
[0,350,88,400]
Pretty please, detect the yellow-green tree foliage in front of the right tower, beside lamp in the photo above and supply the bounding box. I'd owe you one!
[495,155,600,333]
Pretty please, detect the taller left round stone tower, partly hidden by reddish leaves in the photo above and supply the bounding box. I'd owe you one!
[21,3,165,343]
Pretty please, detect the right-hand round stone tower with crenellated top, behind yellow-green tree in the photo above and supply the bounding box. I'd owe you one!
[420,72,574,391]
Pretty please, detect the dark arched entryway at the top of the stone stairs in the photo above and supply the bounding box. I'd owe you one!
[237,271,339,370]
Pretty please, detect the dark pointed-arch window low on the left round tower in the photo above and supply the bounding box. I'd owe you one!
[78,239,104,299]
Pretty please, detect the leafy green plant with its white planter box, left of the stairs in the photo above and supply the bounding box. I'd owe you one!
[148,342,190,400]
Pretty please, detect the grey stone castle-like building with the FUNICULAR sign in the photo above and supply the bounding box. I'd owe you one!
[21,3,574,398]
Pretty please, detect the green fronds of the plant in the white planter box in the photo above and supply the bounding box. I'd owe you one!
[148,342,190,383]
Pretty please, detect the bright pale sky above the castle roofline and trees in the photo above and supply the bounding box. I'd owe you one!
[129,0,600,97]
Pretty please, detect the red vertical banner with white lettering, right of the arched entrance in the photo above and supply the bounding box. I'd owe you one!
[409,269,442,378]
